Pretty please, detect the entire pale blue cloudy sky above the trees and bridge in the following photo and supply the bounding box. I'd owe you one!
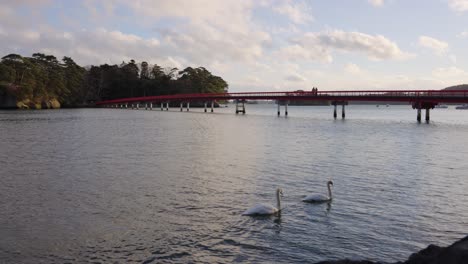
[0,0,468,92]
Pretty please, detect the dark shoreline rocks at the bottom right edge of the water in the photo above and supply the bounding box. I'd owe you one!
[317,236,468,264]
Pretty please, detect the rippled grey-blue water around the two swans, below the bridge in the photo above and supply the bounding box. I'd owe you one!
[0,105,468,263]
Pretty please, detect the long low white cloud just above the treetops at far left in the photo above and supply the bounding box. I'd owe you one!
[0,28,166,65]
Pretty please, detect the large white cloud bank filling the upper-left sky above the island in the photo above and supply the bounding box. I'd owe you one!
[0,0,271,72]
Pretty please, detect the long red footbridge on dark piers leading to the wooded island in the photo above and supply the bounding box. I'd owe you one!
[96,90,468,122]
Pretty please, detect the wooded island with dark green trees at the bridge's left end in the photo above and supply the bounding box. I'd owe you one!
[0,53,228,109]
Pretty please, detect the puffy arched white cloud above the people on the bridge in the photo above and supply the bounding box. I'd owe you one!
[281,30,411,62]
